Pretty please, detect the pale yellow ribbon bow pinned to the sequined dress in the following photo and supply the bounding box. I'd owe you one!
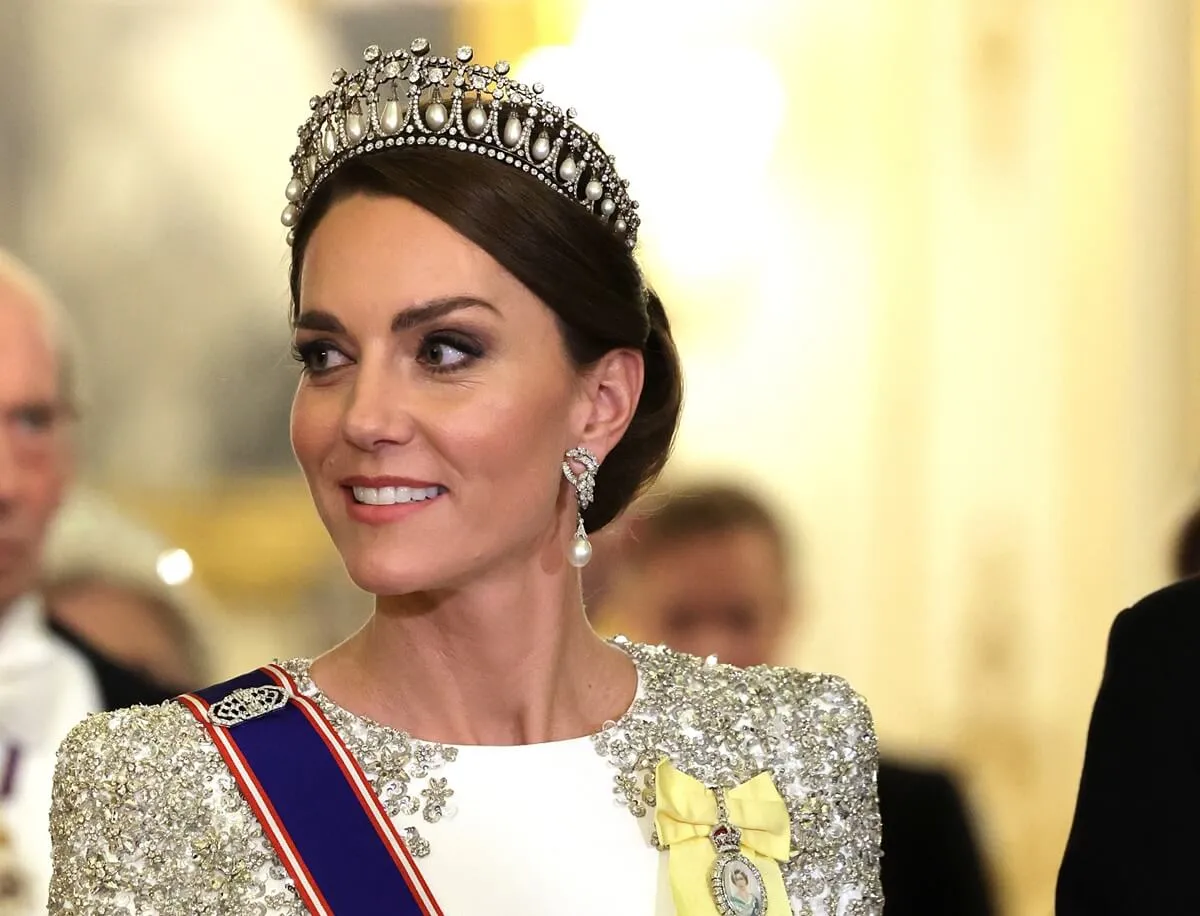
[654,760,792,916]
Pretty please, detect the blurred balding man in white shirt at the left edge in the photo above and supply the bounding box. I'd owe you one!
[0,252,167,912]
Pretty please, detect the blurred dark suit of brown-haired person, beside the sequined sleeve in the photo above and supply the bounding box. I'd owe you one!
[878,758,994,916]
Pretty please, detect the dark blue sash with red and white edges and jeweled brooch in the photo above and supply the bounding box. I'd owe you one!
[178,665,442,916]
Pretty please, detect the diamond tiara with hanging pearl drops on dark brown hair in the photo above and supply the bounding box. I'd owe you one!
[281,38,641,247]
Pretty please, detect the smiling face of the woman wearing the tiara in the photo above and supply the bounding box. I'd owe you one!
[292,196,590,594]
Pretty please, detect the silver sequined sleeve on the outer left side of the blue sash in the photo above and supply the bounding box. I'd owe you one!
[48,701,299,916]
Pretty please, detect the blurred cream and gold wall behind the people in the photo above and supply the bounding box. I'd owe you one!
[0,0,1200,916]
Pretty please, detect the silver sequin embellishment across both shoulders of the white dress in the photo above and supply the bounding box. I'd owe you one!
[49,642,882,916]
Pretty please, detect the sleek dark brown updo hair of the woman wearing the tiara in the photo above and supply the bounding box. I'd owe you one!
[290,148,683,531]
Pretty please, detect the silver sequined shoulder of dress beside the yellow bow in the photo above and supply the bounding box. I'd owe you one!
[609,640,883,916]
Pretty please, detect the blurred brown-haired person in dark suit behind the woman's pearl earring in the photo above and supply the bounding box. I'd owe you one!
[587,483,994,916]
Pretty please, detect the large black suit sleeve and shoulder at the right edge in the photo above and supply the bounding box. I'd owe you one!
[1056,579,1200,916]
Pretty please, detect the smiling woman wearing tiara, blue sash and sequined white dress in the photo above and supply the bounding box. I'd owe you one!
[50,40,881,916]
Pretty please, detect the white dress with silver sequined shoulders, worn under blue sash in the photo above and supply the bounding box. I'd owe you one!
[50,643,882,916]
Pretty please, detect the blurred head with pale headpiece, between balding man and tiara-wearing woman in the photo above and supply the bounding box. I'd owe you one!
[41,489,206,694]
